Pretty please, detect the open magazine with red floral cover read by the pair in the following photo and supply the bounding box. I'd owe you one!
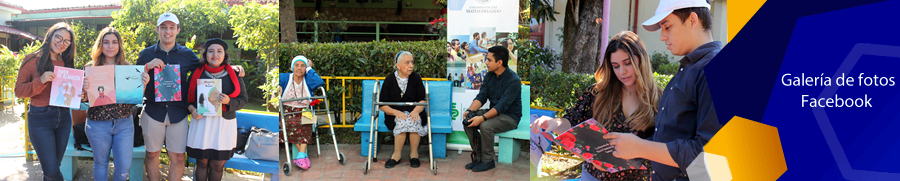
[542,119,647,173]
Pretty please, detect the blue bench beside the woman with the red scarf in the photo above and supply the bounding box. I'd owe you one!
[186,111,281,181]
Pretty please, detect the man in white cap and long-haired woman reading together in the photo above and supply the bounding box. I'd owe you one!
[531,0,722,180]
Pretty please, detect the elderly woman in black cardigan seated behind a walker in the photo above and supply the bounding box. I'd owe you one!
[379,51,428,168]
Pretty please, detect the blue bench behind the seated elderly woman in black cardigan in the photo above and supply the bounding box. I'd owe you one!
[353,80,453,158]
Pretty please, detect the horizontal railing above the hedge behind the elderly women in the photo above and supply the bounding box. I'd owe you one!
[296,20,440,43]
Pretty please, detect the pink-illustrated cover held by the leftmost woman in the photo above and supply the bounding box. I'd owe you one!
[50,66,84,109]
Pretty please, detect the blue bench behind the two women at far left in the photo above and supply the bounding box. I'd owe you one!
[59,131,147,181]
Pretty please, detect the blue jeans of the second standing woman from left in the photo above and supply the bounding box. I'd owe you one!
[84,116,134,181]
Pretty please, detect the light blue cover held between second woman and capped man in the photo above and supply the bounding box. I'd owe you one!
[115,65,144,104]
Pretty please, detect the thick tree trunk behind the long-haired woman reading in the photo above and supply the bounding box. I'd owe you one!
[562,0,603,73]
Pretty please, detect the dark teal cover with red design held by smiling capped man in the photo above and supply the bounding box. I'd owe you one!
[153,65,181,102]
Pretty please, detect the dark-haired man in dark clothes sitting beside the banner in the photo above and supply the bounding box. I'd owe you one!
[463,46,522,172]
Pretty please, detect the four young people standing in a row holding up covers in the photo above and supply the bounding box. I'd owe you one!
[15,13,248,181]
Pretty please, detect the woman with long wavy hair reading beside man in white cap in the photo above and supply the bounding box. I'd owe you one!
[531,31,662,180]
